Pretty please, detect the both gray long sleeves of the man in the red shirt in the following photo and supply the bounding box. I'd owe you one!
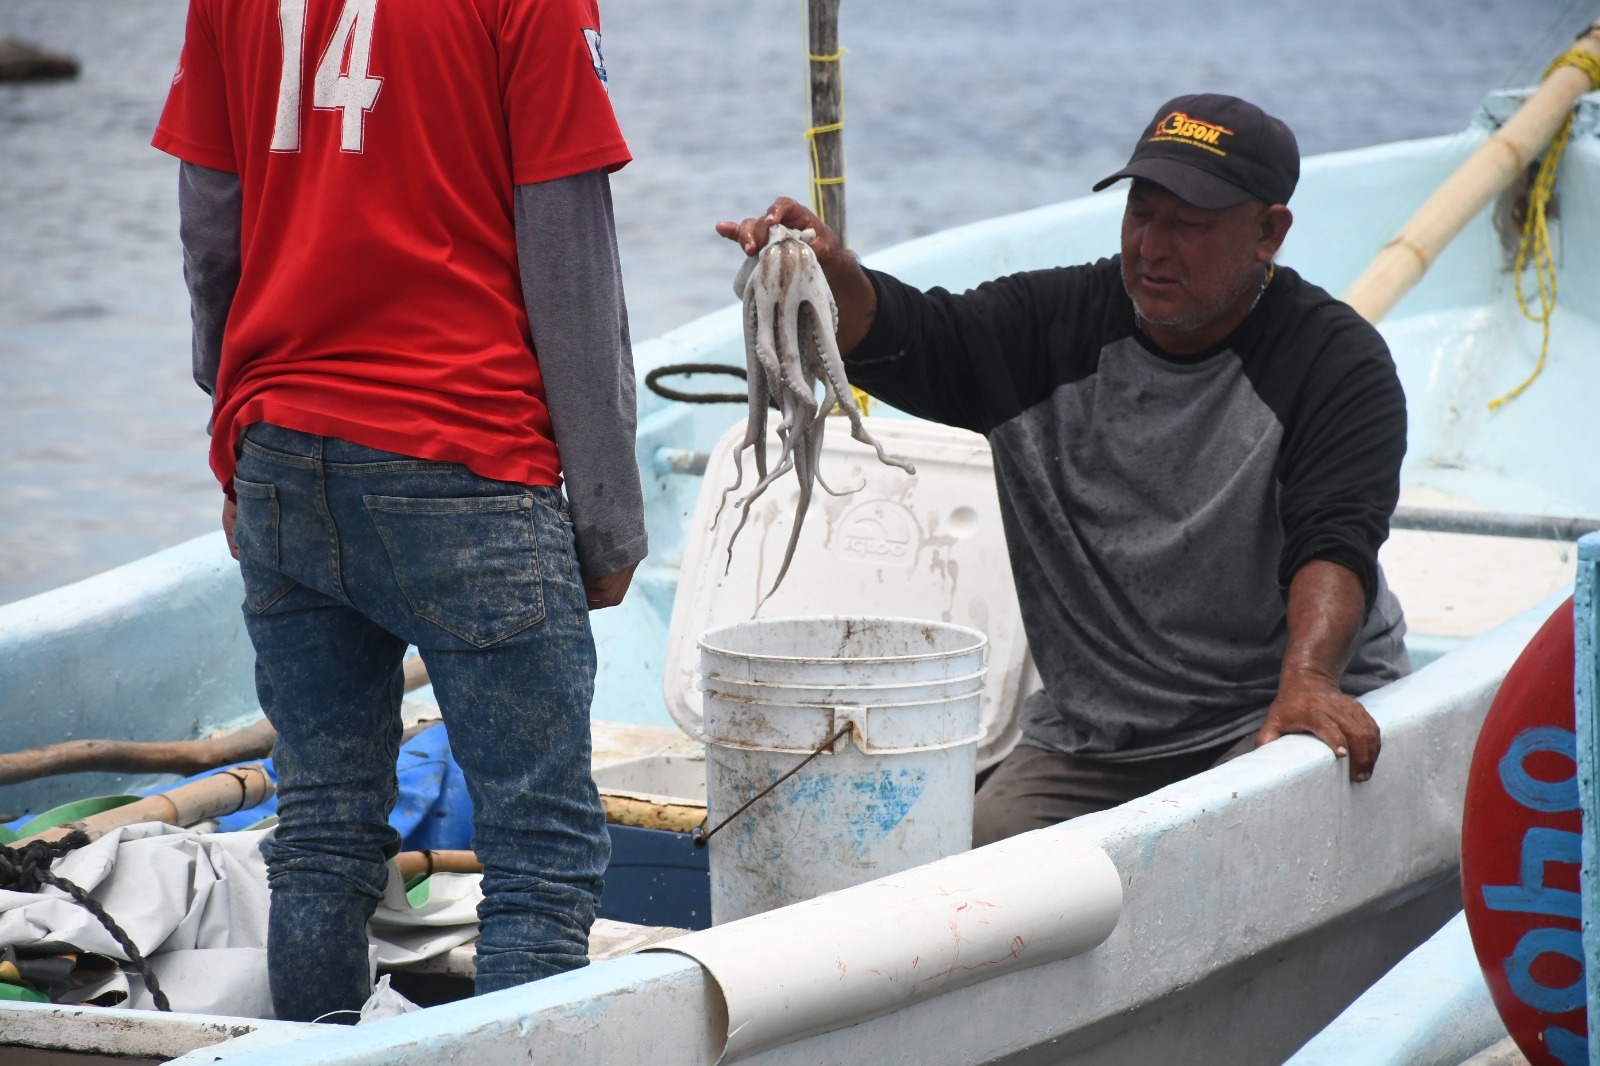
[178,163,648,578]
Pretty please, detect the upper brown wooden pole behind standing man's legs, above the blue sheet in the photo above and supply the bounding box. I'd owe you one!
[0,658,437,784]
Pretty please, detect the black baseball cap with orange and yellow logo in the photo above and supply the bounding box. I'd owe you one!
[1094,93,1299,210]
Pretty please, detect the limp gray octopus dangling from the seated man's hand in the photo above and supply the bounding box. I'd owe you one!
[712,226,917,603]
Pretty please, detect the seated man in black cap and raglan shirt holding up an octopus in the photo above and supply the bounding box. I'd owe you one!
[718,94,1410,844]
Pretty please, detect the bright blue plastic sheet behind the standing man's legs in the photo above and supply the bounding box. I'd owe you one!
[10,725,472,852]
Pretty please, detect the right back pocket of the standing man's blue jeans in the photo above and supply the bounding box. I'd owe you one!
[363,495,544,648]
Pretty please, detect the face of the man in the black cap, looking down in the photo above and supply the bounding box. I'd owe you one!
[1122,179,1286,341]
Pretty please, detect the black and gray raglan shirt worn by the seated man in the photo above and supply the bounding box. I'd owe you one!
[846,258,1410,760]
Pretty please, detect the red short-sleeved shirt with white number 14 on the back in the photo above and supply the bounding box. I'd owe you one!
[154,0,629,487]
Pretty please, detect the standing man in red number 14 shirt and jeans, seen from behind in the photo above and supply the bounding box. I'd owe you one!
[155,0,646,1021]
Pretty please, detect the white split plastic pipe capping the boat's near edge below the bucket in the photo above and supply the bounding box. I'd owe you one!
[651,829,1122,1063]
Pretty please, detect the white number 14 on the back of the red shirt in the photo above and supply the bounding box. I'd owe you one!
[272,0,384,152]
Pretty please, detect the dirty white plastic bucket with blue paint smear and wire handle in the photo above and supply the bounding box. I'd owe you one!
[699,618,989,924]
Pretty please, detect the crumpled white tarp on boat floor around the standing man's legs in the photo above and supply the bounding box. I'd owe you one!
[0,823,480,1018]
